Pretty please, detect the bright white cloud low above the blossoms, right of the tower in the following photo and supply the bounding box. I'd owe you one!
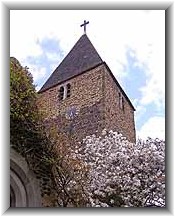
[137,116,165,140]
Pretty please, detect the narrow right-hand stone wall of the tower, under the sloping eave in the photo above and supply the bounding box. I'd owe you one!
[104,64,136,142]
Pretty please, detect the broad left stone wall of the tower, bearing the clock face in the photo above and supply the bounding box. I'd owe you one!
[38,66,104,141]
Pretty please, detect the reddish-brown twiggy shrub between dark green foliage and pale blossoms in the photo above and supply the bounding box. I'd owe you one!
[44,125,88,207]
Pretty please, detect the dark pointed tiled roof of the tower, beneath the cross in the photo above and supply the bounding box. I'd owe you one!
[39,34,103,92]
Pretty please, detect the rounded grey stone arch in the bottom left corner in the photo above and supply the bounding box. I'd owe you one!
[10,149,42,207]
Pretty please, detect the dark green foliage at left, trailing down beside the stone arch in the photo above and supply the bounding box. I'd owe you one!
[10,58,55,205]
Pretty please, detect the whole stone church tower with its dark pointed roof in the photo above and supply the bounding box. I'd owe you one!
[38,34,136,142]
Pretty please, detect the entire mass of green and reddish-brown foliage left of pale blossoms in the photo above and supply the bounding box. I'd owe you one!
[10,58,89,207]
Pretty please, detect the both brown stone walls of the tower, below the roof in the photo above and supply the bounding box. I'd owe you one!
[38,64,135,142]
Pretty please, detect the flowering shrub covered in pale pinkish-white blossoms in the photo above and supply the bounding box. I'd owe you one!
[73,130,165,207]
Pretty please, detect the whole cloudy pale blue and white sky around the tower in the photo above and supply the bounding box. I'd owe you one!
[10,10,165,139]
